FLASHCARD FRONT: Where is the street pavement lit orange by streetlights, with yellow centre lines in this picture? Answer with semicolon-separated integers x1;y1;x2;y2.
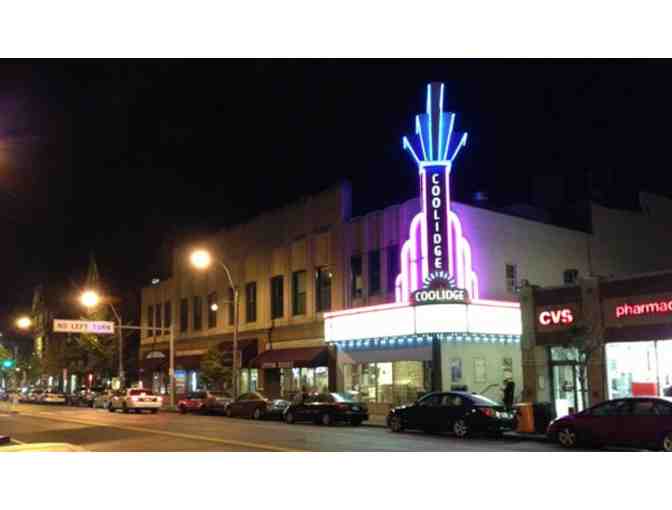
0;404;561;452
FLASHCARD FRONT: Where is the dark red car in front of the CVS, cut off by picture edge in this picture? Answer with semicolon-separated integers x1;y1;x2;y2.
547;397;672;452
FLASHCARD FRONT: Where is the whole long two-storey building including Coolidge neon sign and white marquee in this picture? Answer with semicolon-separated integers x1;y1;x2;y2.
140;84;672;412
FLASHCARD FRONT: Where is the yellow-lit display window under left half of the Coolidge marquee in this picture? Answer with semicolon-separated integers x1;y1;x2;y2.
343;361;431;405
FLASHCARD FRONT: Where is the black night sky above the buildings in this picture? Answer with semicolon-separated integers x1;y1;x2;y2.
0;60;672;331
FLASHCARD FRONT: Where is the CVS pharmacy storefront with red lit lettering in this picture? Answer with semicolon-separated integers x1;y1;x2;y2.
521;272;672;415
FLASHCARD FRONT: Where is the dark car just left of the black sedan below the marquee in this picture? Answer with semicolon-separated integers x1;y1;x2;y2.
284;393;369;425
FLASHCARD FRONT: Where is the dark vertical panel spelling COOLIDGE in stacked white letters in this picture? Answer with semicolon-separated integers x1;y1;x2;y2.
424;165;449;273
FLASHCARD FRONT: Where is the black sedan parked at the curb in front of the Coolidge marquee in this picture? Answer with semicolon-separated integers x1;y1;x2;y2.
387;391;513;438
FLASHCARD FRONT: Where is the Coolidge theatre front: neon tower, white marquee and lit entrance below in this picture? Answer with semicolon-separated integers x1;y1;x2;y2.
325;84;522;408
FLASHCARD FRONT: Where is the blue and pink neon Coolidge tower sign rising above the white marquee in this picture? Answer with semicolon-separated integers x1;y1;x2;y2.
395;83;478;304
